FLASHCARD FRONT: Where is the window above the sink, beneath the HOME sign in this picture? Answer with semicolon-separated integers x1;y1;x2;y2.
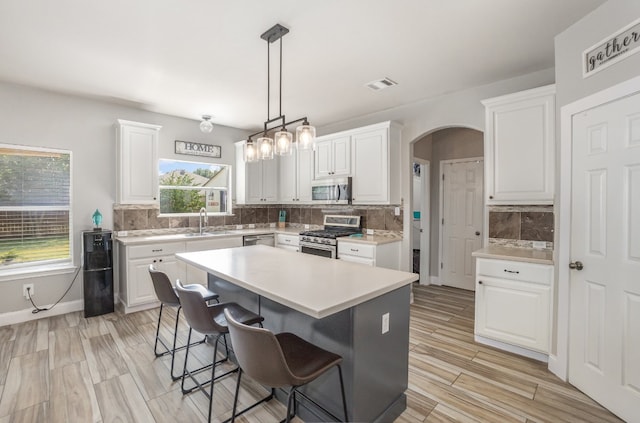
158;159;231;214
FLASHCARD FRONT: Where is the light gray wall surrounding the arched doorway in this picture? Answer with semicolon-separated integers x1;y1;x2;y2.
318;69;554;271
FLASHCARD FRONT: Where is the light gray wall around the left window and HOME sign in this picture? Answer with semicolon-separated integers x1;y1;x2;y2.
0;83;247;316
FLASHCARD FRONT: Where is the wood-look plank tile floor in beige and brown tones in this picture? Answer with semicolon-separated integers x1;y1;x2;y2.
0;286;620;423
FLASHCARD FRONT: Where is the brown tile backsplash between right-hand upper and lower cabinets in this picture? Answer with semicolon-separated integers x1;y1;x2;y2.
489;206;554;250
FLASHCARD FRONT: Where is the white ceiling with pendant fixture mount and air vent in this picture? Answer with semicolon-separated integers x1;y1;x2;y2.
0;0;604;130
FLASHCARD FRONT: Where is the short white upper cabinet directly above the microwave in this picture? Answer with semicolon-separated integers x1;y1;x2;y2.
315;135;351;179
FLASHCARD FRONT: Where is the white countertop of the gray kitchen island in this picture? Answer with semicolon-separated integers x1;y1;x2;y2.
176;245;418;319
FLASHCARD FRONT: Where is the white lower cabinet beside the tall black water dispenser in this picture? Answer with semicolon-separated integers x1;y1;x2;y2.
118;242;186;313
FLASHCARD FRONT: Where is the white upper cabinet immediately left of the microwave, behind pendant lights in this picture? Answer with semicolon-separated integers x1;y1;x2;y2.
279;149;313;204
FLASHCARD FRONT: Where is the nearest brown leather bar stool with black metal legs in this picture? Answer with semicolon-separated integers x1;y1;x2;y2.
225;311;349;423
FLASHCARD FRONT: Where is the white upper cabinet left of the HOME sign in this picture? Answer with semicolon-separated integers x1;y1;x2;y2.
116;119;162;204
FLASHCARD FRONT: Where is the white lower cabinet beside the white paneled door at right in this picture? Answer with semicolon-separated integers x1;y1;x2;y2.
475;258;553;354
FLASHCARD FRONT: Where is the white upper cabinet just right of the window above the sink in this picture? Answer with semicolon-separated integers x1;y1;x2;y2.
236;141;279;204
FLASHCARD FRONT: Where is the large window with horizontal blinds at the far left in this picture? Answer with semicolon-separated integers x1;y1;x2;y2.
0;144;71;271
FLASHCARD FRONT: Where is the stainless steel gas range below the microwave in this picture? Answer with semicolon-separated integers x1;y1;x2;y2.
300;214;362;258
